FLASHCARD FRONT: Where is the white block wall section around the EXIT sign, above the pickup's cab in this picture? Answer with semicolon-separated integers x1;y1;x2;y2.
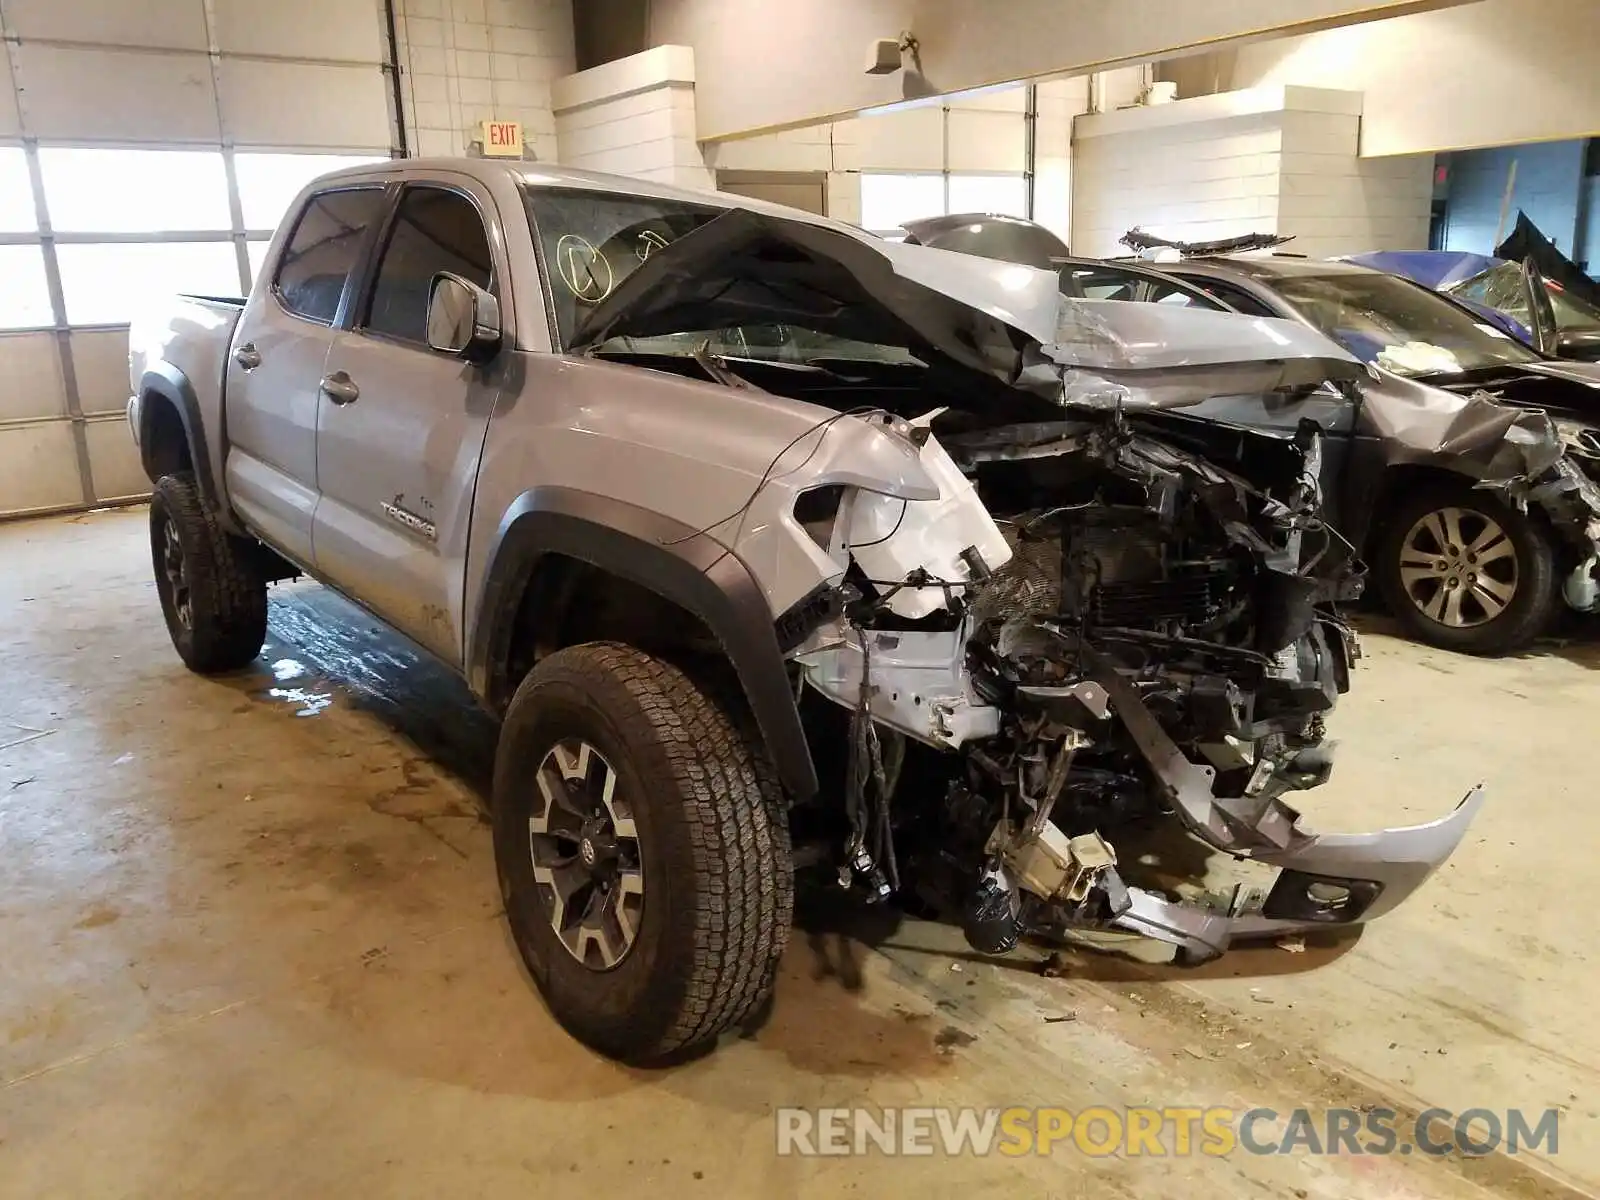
395;0;573;162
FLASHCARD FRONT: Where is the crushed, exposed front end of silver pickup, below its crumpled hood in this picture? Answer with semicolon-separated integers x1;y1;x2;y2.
780;408;1480;960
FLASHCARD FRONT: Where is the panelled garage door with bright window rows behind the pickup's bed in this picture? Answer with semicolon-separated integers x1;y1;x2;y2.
0;0;392;515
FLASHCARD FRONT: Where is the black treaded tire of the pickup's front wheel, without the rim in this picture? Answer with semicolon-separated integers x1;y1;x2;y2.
493;642;794;1066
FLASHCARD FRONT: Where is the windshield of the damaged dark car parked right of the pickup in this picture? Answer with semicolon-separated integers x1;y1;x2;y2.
1275;270;1539;378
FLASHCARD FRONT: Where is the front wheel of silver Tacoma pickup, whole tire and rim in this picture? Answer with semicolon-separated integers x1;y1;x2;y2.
494;642;794;1064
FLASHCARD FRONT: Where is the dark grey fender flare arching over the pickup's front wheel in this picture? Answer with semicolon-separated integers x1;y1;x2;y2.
467;486;818;800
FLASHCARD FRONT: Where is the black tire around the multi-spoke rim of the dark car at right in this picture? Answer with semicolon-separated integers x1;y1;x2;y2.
1376;485;1562;656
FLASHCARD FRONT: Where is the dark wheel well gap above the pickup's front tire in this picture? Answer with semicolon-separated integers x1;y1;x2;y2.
490;554;722;710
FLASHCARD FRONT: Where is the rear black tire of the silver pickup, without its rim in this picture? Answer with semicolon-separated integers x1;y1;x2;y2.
150;472;267;675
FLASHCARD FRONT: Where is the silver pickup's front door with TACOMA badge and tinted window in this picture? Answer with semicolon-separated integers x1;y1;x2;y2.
314;186;510;664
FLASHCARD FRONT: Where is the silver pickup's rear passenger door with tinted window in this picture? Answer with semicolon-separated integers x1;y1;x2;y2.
226;187;384;563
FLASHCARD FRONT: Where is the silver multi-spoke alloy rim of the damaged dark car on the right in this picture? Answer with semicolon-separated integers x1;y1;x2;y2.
1400;507;1517;629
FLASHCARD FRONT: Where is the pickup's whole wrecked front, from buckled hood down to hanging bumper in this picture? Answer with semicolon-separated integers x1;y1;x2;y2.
574;211;1482;960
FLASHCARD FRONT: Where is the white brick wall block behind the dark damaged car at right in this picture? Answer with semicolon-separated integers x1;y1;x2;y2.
1072;88;1434;258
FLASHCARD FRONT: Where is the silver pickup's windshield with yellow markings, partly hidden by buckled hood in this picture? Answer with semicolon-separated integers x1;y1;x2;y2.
525;187;920;365
